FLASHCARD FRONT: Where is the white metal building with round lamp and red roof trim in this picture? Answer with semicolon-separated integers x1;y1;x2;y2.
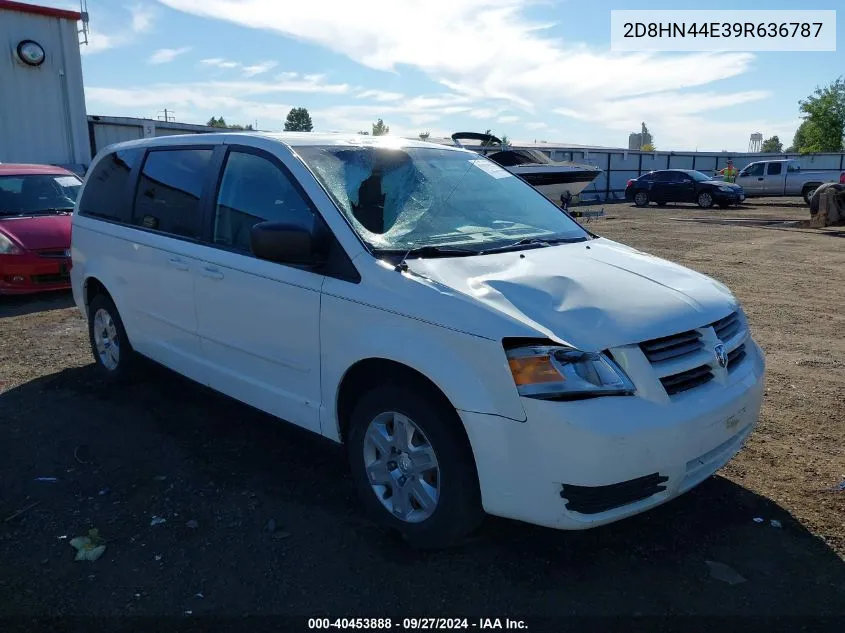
0;0;91;170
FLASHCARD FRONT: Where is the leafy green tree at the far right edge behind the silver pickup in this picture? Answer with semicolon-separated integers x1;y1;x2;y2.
793;76;845;153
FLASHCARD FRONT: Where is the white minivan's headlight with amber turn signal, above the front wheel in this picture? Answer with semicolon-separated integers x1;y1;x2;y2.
507;345;635;400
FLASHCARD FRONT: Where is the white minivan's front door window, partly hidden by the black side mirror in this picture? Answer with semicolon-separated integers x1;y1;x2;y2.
214;151;314;252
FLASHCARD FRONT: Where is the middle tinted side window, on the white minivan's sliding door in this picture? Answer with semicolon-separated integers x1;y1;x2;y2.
132;149;212;239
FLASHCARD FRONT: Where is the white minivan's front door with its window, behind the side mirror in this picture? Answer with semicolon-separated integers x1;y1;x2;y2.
196;147;324;432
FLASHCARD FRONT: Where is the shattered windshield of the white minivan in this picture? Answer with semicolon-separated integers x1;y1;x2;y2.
295;146;588;250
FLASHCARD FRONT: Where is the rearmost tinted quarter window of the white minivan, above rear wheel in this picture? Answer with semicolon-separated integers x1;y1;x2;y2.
79;147;144;223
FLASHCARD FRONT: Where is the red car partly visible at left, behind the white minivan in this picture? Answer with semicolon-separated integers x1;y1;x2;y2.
0;163;82;295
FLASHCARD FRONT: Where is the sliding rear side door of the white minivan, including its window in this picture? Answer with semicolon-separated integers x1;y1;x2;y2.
122;146;214;382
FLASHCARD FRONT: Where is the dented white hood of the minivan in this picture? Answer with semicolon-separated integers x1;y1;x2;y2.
408;239;737;351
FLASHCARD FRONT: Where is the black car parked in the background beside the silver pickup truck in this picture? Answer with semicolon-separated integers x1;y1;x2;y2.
625;169;745;209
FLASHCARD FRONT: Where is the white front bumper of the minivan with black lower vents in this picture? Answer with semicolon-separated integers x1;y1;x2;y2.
460;338;764;530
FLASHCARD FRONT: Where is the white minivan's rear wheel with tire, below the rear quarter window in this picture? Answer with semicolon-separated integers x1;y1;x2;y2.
88;294;138;382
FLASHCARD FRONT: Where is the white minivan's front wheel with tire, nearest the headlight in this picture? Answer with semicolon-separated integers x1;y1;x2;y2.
347;382;484;549
